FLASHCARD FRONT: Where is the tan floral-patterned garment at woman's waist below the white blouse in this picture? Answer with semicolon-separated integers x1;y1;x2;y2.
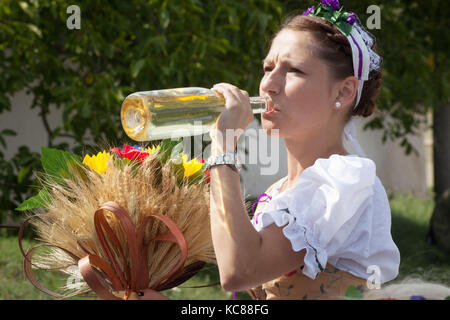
247;264;366;300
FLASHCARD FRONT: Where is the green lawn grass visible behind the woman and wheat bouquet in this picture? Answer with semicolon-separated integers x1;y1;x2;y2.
0;194;450;300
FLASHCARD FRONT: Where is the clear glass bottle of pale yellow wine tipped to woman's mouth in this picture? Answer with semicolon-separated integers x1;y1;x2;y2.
120;87;266;141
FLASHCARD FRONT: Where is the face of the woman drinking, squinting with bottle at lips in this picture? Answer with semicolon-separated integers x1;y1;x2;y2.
259;29;336;139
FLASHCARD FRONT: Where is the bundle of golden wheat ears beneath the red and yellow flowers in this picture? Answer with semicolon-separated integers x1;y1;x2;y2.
20;145;214;298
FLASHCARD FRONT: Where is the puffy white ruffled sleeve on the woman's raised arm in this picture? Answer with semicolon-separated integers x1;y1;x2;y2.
252;155;376;279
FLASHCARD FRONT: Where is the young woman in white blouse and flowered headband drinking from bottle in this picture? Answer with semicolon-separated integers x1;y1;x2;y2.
208;1;400;299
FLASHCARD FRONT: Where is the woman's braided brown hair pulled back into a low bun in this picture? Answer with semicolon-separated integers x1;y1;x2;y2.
280;15;382;117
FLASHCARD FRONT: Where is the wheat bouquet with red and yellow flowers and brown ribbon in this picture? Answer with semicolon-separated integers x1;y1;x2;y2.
17;139;215;299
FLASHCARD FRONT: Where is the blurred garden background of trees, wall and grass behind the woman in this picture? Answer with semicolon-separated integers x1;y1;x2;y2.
0;0;450;299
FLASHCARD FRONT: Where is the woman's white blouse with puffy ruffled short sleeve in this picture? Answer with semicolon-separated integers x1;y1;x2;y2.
252;155;400;283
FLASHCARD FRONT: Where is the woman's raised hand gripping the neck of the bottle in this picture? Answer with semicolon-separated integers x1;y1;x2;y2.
210;83;253;153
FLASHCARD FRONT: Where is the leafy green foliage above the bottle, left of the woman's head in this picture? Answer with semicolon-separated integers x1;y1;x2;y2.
0;0;283;220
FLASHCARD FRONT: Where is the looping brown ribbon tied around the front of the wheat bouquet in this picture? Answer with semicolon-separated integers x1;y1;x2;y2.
19;201;205;300
